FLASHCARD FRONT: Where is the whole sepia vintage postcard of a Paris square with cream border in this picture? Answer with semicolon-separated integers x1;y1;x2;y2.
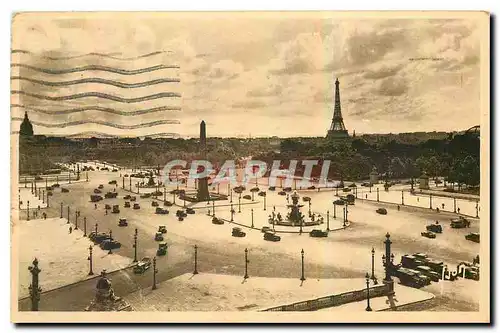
11;11;490;323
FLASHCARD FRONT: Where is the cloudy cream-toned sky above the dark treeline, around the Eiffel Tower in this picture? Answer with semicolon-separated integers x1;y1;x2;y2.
11;12;484;137
